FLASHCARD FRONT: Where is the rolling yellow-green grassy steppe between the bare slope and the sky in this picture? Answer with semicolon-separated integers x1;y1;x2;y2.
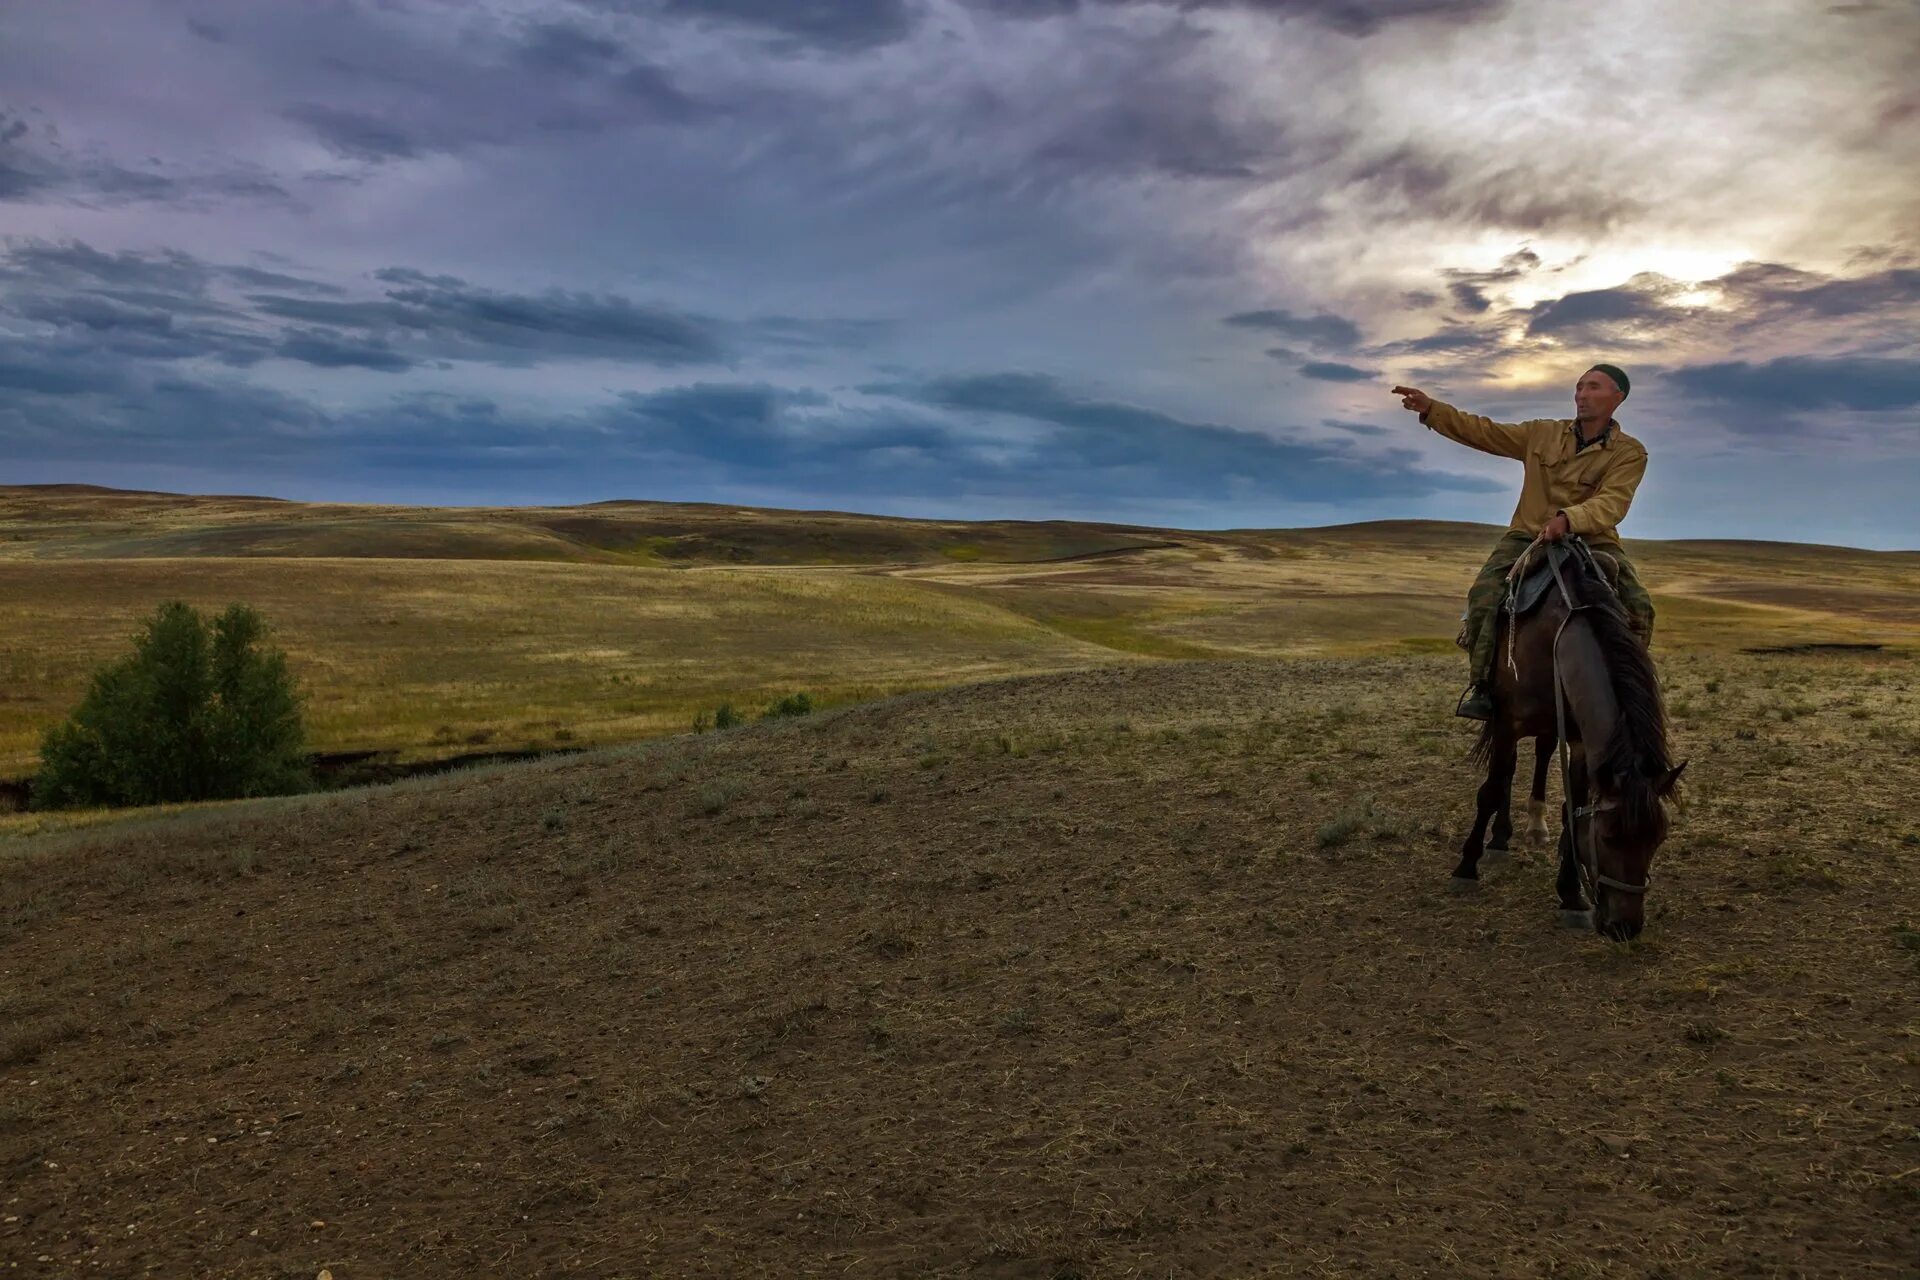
0;487;1920;777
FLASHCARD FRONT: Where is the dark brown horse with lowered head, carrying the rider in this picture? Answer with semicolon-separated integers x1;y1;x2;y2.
1453;537;1686;940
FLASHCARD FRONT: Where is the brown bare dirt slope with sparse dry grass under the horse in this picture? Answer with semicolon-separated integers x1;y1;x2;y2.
0;652;1920;1280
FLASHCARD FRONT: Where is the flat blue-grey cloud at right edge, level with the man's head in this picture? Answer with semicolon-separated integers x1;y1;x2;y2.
1667;355;1920;416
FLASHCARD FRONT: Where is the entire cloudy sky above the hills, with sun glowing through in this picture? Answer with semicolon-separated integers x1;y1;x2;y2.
0;0;1920;547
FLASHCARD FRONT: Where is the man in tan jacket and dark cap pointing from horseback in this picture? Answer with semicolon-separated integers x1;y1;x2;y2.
1394;365;1653;720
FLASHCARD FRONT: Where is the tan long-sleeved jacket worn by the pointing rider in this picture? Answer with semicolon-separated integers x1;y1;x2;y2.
1421;401;1647;543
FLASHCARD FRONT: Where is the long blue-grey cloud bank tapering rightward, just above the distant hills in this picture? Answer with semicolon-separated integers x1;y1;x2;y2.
0;353;1494;505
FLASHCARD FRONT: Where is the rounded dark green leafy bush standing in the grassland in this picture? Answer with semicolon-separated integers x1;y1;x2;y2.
33;601;307;808
